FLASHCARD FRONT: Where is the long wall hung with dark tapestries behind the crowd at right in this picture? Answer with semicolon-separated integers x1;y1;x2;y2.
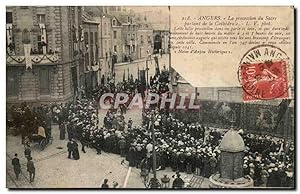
173;69;295;138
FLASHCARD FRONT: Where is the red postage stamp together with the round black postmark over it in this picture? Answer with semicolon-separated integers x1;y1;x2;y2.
238;45;290;101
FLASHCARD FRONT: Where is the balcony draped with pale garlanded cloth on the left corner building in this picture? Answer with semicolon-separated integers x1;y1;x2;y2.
6;53;59;66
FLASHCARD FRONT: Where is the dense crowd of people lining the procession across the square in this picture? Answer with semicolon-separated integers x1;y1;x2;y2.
8;67;295;187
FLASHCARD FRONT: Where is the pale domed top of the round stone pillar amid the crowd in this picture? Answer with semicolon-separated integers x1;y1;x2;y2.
219;129;246;152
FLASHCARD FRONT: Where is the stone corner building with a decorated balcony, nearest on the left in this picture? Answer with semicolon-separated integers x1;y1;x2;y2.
6;6;81;104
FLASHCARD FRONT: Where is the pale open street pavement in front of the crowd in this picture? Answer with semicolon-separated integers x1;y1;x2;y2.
6;105;208;188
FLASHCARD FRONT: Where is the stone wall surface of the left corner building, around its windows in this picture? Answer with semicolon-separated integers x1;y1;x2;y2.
7;6;78;104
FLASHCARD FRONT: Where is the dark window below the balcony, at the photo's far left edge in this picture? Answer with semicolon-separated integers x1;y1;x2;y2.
6;69;19;96
